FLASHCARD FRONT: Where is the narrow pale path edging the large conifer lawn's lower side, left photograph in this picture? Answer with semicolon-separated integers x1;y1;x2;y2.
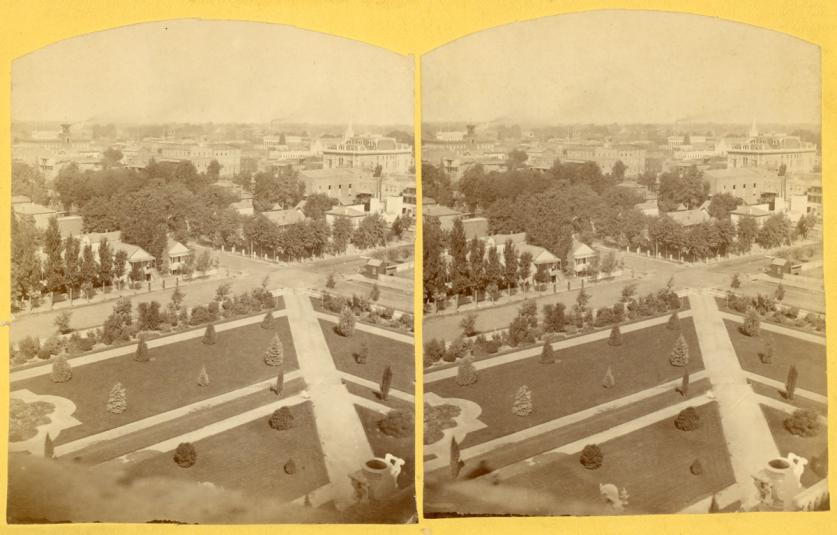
53;370;302;457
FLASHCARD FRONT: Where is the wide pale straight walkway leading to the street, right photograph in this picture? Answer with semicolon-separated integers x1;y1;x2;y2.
689;291;779;507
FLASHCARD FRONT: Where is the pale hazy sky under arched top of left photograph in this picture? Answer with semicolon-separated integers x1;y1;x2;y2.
12;20;413;124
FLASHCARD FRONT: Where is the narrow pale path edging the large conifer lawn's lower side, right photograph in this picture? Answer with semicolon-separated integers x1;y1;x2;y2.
424;371;706;472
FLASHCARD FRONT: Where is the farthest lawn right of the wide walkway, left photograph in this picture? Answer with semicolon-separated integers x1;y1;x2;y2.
319;319;415;394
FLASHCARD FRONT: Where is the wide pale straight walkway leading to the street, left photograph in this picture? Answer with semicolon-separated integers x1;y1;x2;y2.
285;292;374;510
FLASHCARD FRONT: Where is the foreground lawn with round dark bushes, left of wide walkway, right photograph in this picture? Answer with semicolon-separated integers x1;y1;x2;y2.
501;402;735;514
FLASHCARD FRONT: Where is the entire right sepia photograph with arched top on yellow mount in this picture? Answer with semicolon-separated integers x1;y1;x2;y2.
421;11;829;518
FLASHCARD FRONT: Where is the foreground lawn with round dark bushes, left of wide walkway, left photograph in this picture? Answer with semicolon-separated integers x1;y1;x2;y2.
126;402;328;502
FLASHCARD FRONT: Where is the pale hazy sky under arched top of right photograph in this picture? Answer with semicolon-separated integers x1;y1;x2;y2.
422;11;820;123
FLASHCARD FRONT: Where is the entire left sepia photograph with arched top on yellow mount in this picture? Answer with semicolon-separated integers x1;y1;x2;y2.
7;20;417;524
